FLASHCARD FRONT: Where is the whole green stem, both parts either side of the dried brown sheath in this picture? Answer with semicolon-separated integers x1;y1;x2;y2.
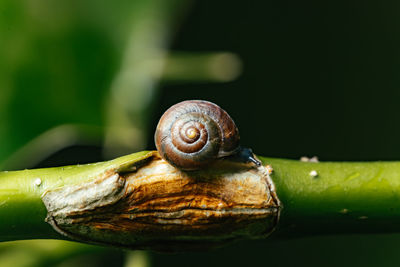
0;152;400;241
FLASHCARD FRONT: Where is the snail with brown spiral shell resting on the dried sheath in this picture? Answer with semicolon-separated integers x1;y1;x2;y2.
154;100;261;170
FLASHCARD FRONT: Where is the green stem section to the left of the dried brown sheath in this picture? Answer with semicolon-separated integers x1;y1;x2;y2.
0;152;151;241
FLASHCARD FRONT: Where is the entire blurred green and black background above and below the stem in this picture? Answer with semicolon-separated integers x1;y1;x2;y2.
0;0;400;267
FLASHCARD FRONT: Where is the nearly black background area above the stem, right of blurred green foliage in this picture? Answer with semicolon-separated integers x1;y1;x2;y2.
155;1;400;161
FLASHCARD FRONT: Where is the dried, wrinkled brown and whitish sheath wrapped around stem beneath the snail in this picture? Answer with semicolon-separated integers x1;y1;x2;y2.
42;153;279;250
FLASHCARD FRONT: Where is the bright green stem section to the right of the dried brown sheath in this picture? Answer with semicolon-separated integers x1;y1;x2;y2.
263;158;400;236
